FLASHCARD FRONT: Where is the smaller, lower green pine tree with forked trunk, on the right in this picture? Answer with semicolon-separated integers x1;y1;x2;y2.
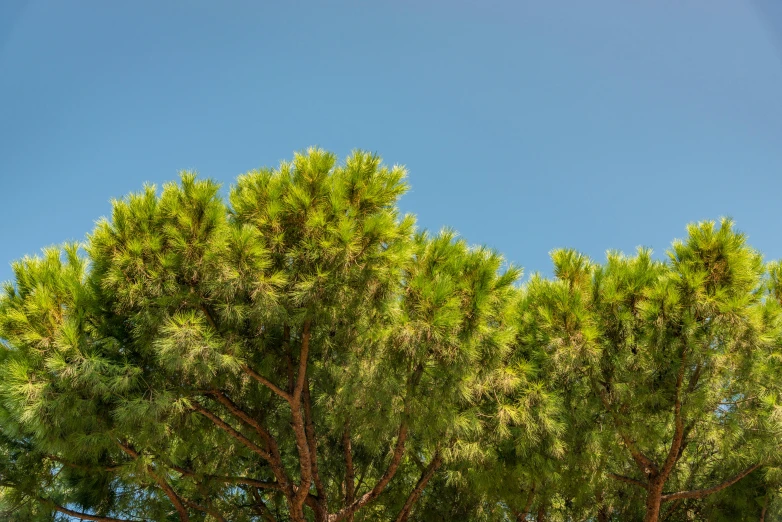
525;220;780;521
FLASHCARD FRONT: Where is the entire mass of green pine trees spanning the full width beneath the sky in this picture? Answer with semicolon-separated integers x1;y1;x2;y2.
0;149;782;522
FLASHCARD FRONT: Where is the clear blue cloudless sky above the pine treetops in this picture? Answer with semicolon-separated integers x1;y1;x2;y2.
0;0;782;280
